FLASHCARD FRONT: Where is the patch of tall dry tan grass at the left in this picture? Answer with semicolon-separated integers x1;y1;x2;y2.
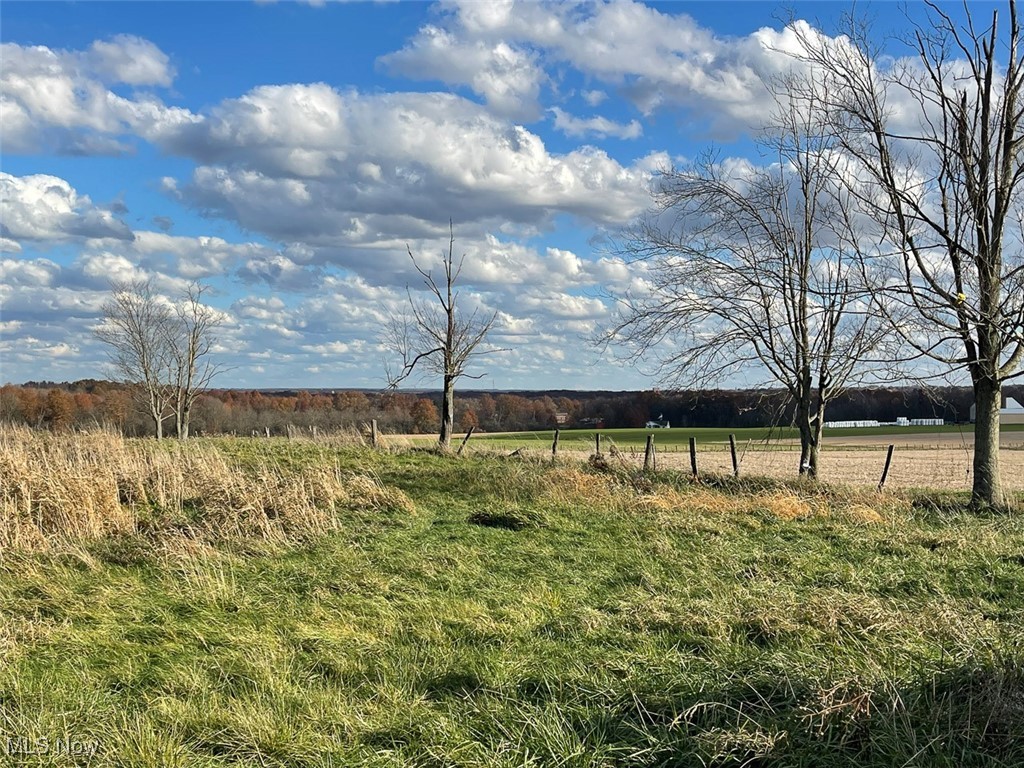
0;426;415;550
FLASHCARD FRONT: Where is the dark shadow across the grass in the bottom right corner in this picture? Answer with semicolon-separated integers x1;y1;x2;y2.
454;663;1024;767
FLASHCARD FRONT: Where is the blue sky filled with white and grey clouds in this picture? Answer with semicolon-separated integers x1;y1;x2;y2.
0;0;995;389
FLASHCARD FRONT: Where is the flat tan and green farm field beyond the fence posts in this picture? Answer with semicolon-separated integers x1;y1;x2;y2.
438;424;1024;490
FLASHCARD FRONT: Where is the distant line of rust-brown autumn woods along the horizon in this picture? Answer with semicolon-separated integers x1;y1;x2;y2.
0;379;1024;436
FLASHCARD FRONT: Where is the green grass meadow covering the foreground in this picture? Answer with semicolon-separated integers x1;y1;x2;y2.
0;442;1024;767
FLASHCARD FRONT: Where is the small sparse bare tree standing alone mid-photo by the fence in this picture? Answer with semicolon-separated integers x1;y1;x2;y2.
383;222;498;451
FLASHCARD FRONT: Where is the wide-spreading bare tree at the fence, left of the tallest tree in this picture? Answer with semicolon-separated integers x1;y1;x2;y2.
604;76;885;478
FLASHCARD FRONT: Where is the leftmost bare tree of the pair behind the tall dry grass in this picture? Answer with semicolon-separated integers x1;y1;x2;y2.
94;281;175;440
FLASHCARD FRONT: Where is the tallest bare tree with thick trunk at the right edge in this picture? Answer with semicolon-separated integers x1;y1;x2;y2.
804;0;1024;506
